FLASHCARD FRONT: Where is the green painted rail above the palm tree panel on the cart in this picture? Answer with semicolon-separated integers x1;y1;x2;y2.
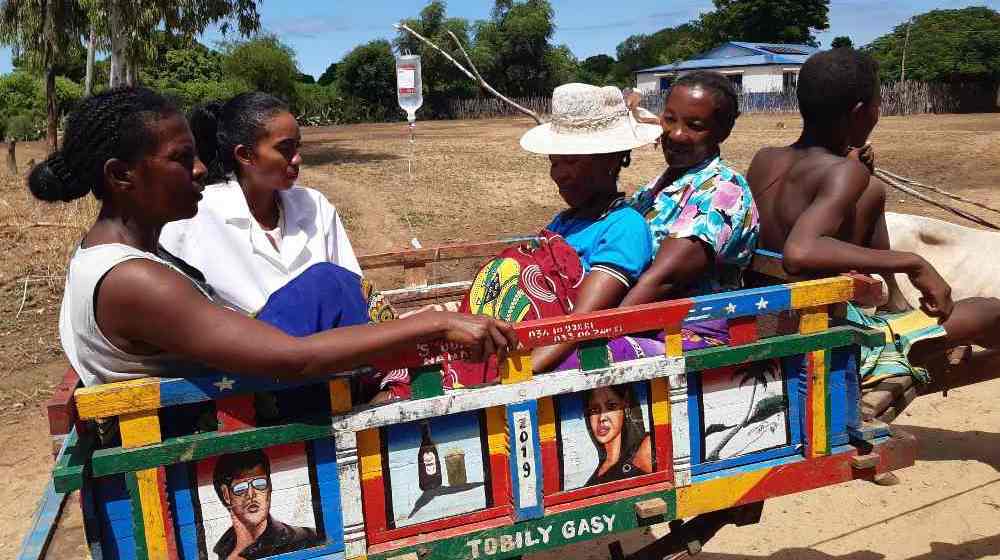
684;327;882;372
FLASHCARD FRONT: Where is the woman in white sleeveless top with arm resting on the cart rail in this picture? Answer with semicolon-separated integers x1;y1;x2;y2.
29;88;517;385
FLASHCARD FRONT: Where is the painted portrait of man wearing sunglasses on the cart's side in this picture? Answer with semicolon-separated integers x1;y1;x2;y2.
212;450;320;560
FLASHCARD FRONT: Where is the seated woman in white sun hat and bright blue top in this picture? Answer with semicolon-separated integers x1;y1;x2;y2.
450;84;662;385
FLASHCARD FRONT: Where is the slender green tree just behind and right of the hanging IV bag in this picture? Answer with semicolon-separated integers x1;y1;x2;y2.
393;0;477;116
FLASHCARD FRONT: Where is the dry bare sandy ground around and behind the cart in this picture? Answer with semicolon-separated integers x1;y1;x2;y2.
0;114;1000;560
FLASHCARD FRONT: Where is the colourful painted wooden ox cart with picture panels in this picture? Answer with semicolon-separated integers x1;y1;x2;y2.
22;242;928;560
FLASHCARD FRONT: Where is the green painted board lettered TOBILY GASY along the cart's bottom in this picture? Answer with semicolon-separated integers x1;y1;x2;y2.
368;490;677;560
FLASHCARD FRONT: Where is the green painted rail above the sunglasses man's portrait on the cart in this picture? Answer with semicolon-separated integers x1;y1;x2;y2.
91;418;333;476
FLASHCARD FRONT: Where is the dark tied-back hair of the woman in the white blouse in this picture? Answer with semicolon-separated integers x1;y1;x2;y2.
188;91;289;183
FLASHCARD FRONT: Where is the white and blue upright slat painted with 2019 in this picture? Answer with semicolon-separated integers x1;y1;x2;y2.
507;401;543;521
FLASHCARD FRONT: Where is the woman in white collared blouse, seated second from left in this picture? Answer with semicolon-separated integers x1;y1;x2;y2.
160;92;361;314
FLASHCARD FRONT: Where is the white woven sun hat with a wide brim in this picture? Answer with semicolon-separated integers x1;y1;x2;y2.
521;84;663;155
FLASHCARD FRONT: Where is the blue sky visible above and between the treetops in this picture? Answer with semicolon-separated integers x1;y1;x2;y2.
0;0;1000;77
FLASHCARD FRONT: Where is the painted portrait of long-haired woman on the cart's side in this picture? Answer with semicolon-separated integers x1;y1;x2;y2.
584;385;653;486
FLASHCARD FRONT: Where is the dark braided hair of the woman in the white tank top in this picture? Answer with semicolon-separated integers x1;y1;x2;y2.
28;87;178;202
